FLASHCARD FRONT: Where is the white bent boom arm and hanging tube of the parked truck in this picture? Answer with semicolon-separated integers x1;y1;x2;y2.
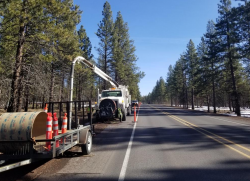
69;56;119;130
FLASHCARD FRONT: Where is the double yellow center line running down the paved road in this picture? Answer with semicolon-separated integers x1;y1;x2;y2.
150;106;250;159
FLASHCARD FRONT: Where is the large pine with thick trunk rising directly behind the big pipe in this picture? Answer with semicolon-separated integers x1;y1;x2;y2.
0;0;50;112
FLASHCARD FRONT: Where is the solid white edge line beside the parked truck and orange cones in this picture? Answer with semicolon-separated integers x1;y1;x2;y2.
118;108;140;181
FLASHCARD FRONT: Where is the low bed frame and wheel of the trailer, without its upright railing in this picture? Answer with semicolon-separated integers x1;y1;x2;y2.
0;125;92;172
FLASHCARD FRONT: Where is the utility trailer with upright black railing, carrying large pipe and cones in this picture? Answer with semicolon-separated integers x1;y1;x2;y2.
0;101;94;173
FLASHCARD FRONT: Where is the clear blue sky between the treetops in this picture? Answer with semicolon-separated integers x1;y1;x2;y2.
74;0;243;95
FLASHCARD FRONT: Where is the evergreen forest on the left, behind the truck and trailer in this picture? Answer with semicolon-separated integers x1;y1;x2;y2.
0;0;144;112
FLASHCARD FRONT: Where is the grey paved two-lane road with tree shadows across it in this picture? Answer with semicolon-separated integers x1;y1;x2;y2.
21;105;250;181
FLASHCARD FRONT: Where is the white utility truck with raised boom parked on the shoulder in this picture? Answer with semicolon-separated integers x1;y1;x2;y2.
69;56;131;121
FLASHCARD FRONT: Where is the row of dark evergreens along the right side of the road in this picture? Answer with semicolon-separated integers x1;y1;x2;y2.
142;0;250;116
